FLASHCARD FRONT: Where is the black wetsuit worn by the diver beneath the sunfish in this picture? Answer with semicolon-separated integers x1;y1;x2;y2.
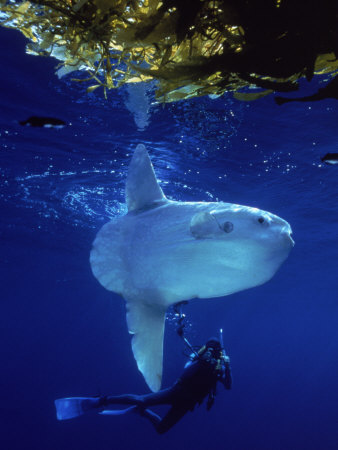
101;348;232;434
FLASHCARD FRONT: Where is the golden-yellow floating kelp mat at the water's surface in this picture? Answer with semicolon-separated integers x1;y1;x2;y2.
0;0;338;101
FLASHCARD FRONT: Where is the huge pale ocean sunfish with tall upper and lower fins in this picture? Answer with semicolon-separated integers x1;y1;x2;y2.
90;144;294;391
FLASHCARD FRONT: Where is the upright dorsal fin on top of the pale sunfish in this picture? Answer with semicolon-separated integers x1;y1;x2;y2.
126;144;166;211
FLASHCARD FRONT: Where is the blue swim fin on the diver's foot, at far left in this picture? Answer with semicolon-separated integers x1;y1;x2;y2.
55;397;102;420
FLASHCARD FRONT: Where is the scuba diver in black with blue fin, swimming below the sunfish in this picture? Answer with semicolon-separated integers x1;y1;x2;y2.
55;337;232;434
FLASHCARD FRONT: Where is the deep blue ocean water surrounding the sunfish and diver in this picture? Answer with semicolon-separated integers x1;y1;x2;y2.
0;29;338;450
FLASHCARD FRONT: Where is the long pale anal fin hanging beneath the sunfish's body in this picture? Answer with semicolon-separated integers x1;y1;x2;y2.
127;299;165;391
